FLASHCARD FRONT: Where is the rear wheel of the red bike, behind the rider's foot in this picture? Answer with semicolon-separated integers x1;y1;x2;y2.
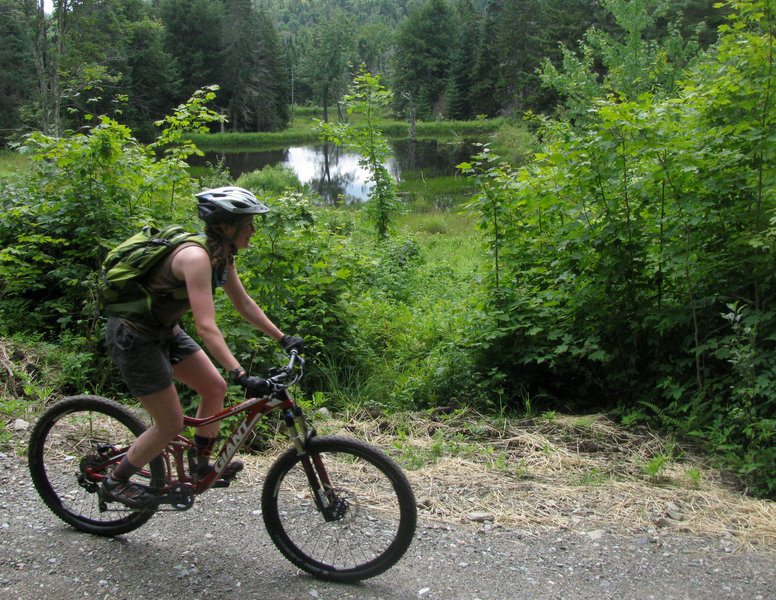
28;396;166;536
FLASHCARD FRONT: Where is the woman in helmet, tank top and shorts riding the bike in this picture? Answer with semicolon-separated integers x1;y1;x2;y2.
101;187;304;508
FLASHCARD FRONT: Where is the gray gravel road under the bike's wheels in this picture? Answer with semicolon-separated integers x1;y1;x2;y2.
0;455;776;600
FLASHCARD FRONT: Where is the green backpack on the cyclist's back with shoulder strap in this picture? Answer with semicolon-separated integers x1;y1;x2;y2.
99;225;208;322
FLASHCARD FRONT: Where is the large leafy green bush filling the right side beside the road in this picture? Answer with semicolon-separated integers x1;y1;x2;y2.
462;2;776;495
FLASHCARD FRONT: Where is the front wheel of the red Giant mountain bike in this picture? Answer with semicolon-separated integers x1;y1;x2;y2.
262;436;417;583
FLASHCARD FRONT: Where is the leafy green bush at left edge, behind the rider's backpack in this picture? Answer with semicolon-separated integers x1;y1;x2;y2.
0;91;220;339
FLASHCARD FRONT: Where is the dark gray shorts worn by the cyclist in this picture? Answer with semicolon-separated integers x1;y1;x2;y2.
105;317;201;398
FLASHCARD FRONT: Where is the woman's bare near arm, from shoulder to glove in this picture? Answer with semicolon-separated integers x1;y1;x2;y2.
172;246;240;371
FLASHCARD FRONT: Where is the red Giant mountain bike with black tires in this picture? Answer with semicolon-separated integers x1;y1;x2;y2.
28;352;417;583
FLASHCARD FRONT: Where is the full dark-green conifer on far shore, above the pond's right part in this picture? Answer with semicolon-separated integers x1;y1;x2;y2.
392;0;456;119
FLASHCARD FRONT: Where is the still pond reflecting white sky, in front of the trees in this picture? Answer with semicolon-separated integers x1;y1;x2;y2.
197;139;477;202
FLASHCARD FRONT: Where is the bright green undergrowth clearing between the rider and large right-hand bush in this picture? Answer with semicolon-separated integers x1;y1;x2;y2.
327;204;484;411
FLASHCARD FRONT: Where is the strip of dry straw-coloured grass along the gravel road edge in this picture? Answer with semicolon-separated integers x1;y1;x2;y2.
239;412;776;549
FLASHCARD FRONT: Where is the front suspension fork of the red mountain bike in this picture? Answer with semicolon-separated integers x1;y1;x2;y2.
283;406;348;522
